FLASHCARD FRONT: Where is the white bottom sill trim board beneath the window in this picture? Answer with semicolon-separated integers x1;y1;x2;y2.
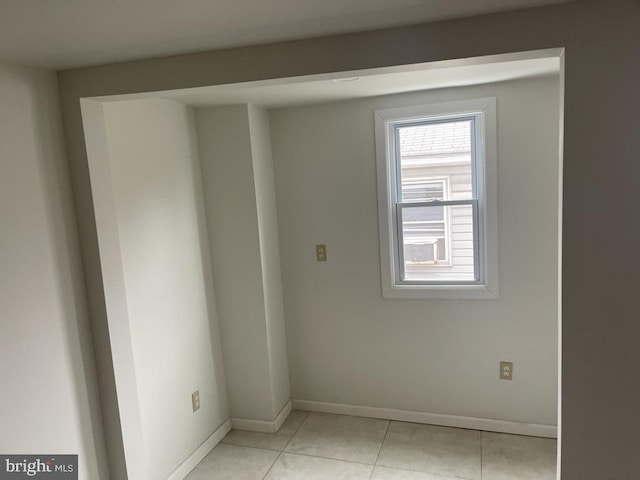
382;285;499;300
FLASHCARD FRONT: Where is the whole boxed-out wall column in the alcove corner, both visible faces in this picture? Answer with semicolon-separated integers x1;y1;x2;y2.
196;105;290;427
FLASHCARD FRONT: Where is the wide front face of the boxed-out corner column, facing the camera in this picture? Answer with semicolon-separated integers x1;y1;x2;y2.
196;105;272;421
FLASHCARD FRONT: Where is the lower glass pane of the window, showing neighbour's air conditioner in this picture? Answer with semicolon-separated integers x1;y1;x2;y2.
400;204;476;282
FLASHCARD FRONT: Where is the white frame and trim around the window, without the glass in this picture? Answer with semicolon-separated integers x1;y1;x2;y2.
375;97;499;299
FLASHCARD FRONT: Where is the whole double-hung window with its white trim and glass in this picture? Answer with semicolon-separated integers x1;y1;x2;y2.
376;98;498;298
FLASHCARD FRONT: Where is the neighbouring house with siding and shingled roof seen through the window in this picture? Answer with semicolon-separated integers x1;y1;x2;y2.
395;118;477;281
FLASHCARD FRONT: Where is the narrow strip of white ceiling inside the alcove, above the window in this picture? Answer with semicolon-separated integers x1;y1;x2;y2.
99;49;560;108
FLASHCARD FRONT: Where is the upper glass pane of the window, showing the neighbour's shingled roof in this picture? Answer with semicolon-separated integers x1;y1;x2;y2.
397;119;473;202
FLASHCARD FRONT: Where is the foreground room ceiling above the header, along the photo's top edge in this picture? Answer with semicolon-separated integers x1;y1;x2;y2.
0;0;567;69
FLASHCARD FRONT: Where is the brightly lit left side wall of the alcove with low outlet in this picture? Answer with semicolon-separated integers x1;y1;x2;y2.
98;100;228;480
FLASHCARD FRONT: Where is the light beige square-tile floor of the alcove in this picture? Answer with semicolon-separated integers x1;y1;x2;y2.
187;411;556;480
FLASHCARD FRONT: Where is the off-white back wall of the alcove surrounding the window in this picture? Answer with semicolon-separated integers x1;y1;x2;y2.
270;77;559;424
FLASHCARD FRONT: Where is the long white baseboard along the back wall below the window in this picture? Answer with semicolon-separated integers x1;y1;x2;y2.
292;400;558;438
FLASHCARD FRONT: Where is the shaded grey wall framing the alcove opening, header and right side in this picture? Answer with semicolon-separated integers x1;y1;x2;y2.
59;0;640;480
